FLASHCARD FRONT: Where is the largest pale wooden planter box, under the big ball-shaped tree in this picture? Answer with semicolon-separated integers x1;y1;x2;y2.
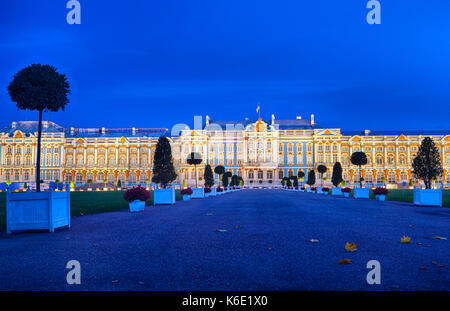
6;190;70;234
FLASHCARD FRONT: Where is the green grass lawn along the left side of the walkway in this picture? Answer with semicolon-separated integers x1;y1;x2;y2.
0;190;182;231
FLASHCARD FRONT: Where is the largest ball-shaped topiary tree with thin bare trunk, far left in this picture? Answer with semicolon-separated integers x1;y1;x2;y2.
8;64;70;192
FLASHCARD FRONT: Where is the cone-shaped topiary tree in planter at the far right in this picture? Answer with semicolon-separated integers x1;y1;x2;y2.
412;137;443;189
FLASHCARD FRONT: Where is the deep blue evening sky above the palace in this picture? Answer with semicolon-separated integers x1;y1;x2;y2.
0;0;450;130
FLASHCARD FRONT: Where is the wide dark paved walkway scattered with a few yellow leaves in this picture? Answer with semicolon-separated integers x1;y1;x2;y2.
0;190;450;290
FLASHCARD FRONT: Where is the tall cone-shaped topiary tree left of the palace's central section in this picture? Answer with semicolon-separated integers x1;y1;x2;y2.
152;136;177;188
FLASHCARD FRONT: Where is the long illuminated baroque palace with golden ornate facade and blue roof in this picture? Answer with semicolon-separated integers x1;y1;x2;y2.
0;115;450;187
